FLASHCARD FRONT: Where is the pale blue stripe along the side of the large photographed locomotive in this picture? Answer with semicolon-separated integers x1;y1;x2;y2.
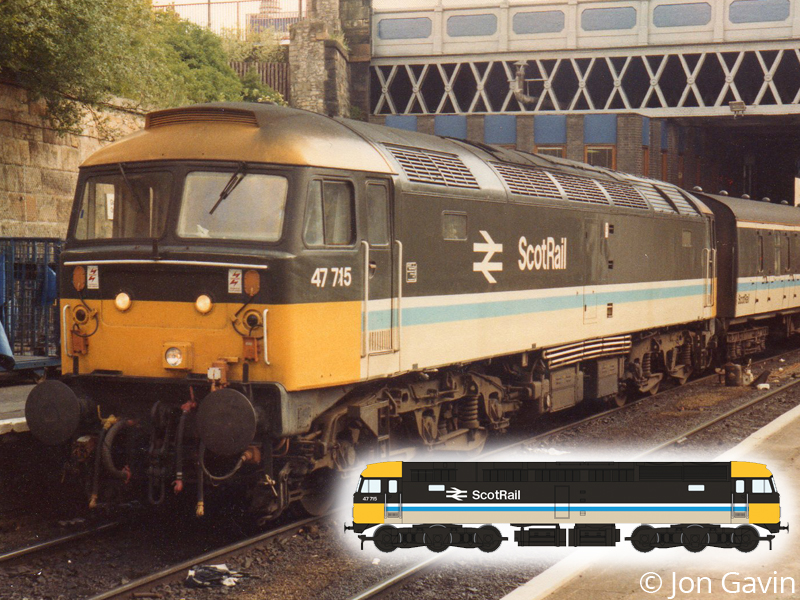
369;284;705;331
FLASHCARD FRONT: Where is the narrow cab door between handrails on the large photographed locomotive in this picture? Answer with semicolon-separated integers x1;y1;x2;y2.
361;180;400;378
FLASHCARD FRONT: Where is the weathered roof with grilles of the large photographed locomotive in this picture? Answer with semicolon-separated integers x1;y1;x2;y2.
82;102;708;217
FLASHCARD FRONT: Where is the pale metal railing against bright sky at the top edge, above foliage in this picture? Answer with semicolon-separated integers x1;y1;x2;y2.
153;0;306;38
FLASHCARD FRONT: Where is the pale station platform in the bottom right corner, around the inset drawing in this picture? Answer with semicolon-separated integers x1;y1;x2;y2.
503;406;800;600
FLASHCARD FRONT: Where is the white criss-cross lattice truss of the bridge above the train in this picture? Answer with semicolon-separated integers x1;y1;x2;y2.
372;42;800;117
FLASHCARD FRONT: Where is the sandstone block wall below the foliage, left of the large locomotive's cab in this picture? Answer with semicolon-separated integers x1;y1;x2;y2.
0;82;144;238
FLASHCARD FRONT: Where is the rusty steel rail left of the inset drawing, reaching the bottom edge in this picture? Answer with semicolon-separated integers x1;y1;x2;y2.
86;513;324;600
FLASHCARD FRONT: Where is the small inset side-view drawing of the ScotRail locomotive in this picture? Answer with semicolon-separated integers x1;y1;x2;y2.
346;461;789;552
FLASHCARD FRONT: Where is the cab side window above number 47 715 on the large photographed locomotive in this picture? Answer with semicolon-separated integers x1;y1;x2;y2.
303;180;356;246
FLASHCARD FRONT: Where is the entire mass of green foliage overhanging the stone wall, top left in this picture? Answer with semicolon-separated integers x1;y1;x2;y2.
0;0;270;131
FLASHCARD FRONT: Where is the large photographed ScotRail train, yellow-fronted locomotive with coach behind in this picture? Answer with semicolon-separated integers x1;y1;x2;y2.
20;103;800;519
